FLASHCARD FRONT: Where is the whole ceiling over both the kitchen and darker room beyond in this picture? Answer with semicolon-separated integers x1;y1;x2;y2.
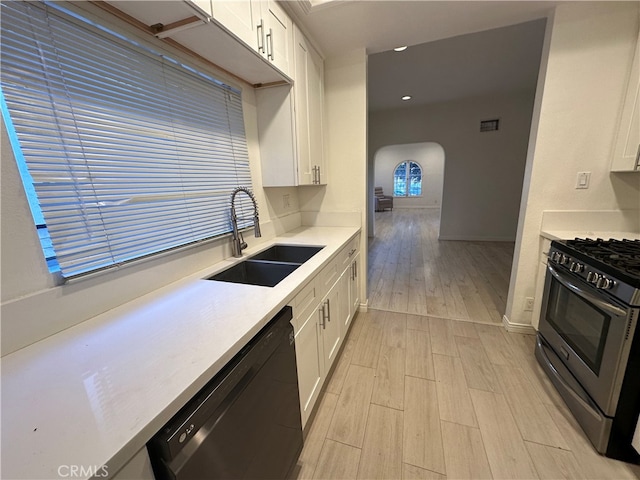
287;0;560;111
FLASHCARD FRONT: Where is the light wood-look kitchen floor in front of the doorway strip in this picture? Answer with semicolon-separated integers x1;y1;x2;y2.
292;310;640;480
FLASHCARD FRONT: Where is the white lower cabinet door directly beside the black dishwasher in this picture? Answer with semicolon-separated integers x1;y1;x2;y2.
296;309;324;427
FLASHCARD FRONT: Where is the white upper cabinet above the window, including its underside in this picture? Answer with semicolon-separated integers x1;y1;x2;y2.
107;0;293;86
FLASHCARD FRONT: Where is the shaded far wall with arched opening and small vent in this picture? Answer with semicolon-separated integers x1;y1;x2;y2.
369;92;534;241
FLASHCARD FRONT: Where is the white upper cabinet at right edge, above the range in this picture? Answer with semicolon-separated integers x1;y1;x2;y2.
611;32;640;172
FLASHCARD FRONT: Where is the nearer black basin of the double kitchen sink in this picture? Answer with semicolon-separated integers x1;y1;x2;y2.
207;259;301;287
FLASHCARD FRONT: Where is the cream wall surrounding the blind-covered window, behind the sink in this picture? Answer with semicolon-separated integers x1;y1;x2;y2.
0;5;300;355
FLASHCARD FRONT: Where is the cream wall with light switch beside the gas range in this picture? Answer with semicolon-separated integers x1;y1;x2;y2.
506;2;640;325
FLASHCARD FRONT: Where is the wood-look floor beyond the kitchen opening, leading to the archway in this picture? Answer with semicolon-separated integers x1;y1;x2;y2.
368;209;514;323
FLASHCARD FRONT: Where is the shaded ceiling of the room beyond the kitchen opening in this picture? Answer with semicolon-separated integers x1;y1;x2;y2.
367;20;545;111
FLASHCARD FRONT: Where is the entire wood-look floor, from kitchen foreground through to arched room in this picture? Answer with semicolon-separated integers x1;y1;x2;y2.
292;210;640;480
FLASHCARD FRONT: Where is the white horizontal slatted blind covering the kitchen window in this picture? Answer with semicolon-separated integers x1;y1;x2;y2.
0;1;251;278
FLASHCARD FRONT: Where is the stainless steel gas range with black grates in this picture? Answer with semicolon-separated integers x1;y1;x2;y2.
536;239;640;463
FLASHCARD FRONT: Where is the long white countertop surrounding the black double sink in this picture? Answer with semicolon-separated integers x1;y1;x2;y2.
1;227;358;479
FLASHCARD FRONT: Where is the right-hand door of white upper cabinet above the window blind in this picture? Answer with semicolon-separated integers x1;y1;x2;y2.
262;0;293;76
